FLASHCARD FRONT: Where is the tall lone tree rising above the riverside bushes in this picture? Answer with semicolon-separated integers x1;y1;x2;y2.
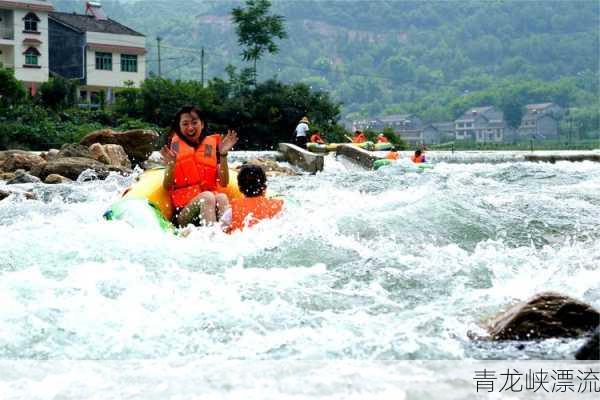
231;0;287;85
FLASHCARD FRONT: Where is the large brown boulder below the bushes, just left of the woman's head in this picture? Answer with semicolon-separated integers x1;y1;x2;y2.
79;129;159;164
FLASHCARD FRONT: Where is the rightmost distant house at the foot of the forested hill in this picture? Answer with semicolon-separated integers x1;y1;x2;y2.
518;103;564;139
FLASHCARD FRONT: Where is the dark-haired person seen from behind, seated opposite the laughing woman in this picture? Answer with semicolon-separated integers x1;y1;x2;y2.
221;164;283;233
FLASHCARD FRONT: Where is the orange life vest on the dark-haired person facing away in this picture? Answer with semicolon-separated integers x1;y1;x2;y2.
229;196;283;232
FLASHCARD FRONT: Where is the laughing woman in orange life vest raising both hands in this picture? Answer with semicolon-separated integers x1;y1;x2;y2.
160;106;238;226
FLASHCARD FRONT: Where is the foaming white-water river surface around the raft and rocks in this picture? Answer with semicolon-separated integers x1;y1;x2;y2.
0;152;600;396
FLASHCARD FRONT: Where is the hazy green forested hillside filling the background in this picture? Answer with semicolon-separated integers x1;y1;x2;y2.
53;0;600;126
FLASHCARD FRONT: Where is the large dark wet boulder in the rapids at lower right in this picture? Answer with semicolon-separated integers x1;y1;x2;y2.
488;292;600;340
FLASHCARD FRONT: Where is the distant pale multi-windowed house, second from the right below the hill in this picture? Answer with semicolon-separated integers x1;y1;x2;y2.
454;106;508;143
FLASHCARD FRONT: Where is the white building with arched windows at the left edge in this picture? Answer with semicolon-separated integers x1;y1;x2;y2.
0;0;54;95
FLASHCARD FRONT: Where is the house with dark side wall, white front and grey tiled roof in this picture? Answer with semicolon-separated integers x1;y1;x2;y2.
49;2;146;104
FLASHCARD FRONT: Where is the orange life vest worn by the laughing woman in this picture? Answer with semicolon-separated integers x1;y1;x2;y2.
169;134;221;208
